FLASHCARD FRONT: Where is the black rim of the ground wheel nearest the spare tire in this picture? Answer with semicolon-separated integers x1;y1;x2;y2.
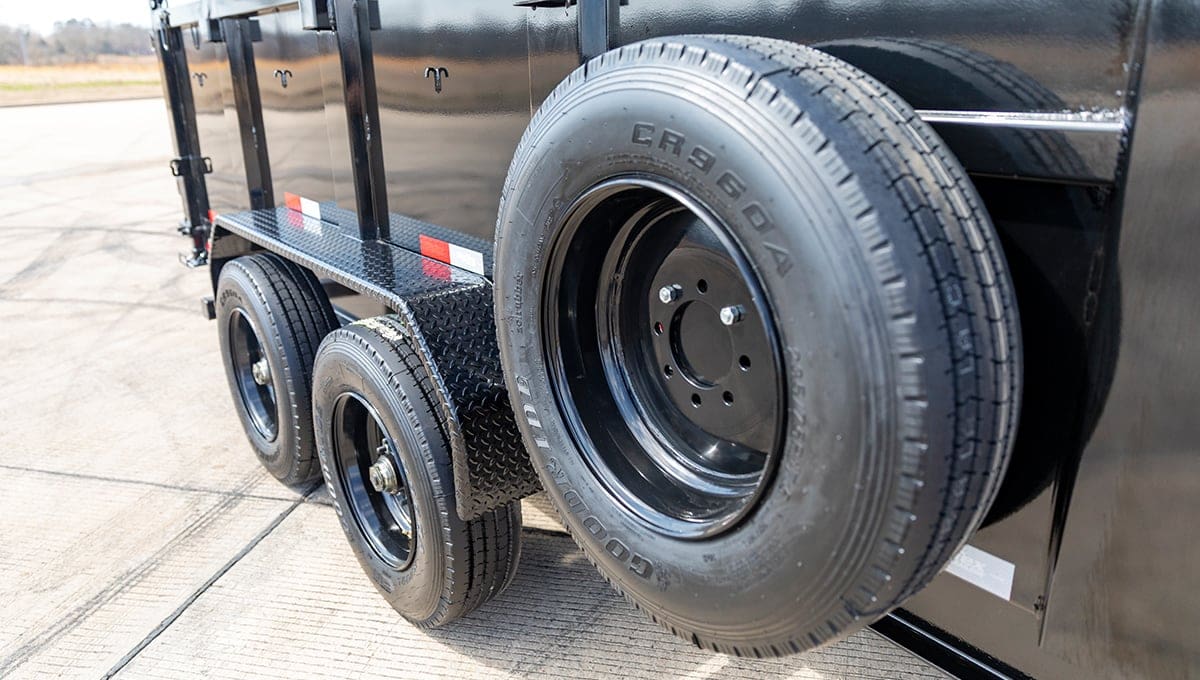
332;392;416;570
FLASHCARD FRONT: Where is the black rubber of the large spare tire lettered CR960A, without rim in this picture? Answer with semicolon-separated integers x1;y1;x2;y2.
494;36;1021;656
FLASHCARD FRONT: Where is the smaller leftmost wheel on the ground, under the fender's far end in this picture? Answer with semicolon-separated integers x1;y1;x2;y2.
216;253;338;486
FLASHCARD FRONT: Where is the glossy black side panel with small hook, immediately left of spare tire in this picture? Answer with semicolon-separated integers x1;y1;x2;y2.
371;0;530;240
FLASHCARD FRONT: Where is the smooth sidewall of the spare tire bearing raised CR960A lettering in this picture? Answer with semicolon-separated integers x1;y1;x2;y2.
496;71;892;640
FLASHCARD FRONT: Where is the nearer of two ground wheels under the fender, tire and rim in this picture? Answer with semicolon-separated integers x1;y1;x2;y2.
313;317;521;627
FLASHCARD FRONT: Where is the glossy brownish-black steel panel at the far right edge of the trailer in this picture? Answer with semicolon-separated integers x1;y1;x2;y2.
1044;0;1200;679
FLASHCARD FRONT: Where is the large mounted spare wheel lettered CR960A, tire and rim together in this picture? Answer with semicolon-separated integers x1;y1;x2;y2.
496;36;1020;656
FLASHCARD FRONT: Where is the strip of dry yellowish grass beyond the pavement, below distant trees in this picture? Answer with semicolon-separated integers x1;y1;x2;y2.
0;56;162;107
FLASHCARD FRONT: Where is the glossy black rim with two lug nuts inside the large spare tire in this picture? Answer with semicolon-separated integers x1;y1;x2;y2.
542;176;785;537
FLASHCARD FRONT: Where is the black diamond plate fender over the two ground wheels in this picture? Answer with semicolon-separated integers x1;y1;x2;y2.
210;204;541;519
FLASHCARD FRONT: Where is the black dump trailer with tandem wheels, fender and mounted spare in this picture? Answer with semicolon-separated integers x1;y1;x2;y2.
154;0;1200;679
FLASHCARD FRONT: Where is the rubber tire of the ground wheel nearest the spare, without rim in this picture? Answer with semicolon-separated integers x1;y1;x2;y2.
313;317;521;627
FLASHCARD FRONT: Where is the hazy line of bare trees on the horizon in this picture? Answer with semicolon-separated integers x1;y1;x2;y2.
0;19;154;66
